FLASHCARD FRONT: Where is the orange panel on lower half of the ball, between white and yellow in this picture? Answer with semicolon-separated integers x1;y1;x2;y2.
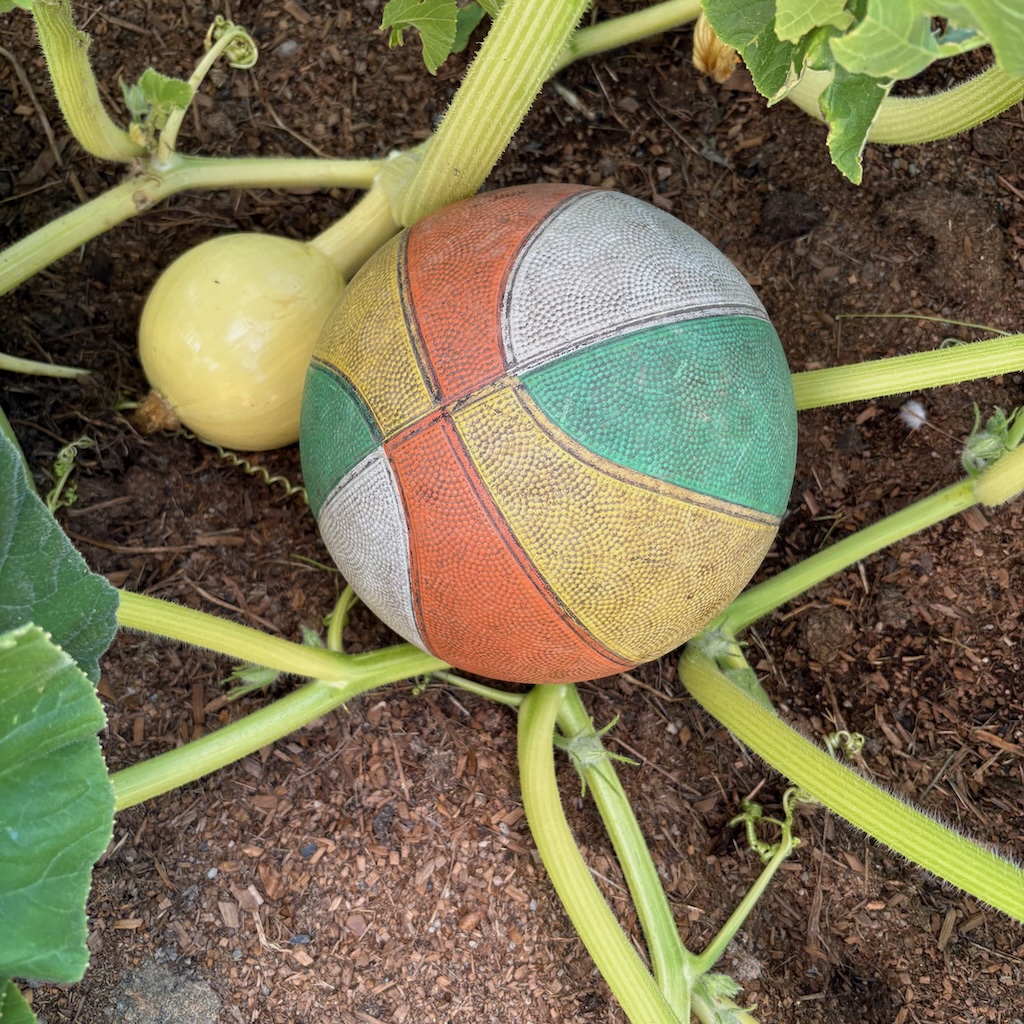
384;413;632;683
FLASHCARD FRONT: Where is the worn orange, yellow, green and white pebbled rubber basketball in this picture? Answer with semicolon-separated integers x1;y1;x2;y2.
301;185;797;683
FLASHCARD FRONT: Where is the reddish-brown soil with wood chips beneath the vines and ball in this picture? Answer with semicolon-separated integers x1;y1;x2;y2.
0;0;1024;1024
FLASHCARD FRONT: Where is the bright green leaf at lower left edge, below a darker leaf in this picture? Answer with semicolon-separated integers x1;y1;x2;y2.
0;625;114;982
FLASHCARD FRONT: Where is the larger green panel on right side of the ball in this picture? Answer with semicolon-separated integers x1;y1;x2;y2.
521;316;797;517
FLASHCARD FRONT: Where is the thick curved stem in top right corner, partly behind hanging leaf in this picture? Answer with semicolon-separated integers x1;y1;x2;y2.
785;68;1024;145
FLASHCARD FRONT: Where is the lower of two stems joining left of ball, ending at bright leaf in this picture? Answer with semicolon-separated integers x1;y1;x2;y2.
111;644;435;811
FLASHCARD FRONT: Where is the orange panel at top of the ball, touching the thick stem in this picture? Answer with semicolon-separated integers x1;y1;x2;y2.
402;184;587;402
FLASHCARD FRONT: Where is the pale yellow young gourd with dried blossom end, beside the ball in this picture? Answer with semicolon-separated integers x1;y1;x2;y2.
139;233;344;452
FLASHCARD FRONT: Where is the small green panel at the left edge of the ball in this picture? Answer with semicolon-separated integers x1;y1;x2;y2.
299;362;381;516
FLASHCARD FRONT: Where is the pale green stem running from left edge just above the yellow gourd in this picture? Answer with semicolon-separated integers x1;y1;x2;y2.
0;156;383;295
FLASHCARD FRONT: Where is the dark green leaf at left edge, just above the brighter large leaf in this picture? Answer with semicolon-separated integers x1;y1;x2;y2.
0;433;118;682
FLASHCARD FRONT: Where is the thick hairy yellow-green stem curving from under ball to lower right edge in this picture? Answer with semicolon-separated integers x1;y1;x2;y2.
679;647;1024;921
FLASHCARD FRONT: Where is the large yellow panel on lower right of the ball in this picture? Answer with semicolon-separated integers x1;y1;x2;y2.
453;383;776;663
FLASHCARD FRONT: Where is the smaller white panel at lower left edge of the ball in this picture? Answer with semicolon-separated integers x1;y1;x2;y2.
319;449;424;647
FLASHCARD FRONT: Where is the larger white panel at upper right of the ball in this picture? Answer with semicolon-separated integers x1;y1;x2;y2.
502;191;768;373
